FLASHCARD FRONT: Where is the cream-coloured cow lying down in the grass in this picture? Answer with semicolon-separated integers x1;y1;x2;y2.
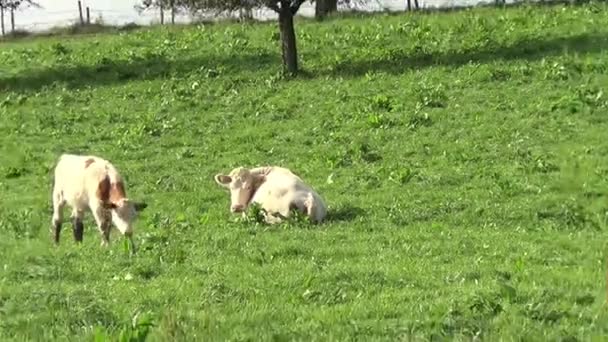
215;166;327;224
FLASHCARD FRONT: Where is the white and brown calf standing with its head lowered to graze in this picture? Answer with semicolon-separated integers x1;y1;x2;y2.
52;154;146;248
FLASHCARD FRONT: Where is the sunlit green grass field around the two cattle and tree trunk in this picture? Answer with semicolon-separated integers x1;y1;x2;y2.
0;3;608;341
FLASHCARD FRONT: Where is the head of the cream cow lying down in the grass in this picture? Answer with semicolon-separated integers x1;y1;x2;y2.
215;167;265;213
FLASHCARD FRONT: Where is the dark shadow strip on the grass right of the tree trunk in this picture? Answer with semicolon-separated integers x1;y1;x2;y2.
326;33;608;77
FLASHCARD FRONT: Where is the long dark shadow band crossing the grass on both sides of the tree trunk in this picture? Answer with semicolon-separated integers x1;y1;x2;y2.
0;33;608;91
